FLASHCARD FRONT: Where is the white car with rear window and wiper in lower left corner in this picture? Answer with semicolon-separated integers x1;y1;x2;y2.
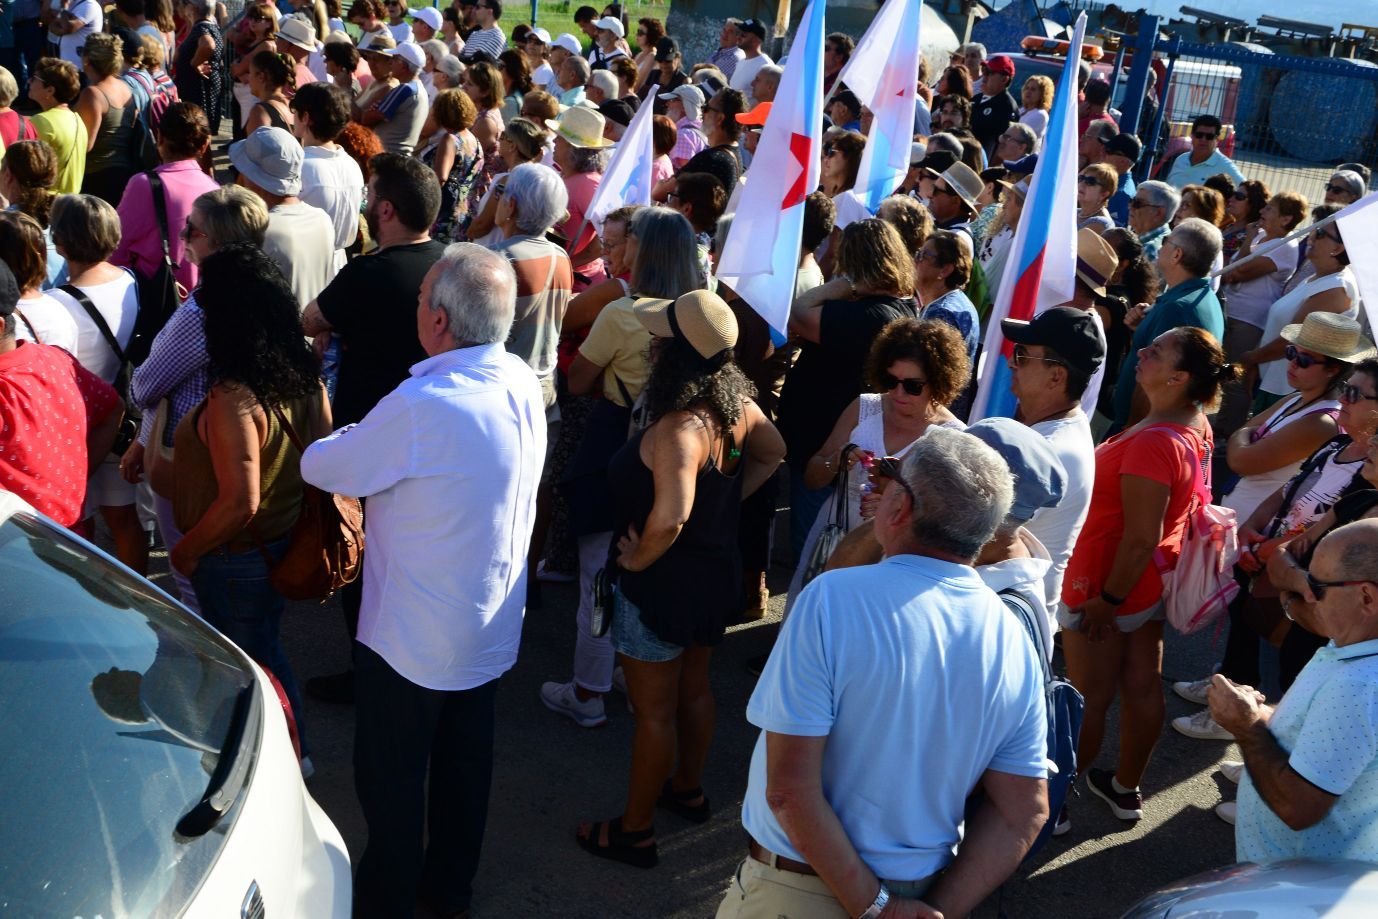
0;492;351;919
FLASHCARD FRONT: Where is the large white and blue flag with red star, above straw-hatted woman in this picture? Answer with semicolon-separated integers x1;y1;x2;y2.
718;0;825;340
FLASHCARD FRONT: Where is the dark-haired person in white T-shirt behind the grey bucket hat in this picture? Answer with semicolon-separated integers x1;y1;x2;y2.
292;83;364;270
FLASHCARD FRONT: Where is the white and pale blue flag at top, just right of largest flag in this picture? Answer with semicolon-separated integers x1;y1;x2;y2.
838;0;923;214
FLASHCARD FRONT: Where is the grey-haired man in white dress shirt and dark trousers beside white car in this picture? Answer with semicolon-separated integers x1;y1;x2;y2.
302;242;546;916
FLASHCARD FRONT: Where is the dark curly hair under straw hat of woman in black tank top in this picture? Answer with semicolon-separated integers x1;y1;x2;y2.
646;338;757;426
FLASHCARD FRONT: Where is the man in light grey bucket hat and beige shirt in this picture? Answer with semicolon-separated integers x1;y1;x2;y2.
230;127;339;309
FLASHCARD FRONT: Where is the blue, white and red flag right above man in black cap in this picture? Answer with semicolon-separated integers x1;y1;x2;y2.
971;12;1086;422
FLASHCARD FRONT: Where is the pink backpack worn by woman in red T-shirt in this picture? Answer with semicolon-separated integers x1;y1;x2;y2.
1145;424;1239;635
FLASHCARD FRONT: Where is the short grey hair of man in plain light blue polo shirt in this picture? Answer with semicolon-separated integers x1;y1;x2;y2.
900;427;1014;562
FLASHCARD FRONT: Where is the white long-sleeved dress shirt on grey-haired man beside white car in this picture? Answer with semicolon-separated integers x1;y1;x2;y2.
302;343;546;690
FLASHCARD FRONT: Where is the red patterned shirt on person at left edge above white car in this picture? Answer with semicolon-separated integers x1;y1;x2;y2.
0;342;123;526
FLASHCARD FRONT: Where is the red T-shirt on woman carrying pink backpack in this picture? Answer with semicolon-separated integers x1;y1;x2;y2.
1062;424;1211;616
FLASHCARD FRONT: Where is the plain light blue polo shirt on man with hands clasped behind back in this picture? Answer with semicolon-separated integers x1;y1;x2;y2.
741;555;1047;880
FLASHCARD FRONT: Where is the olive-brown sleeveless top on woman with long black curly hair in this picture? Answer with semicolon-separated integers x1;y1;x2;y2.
172;393;320;553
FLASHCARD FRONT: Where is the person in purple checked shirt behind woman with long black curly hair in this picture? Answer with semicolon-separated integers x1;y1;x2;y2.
121;185;267;609
